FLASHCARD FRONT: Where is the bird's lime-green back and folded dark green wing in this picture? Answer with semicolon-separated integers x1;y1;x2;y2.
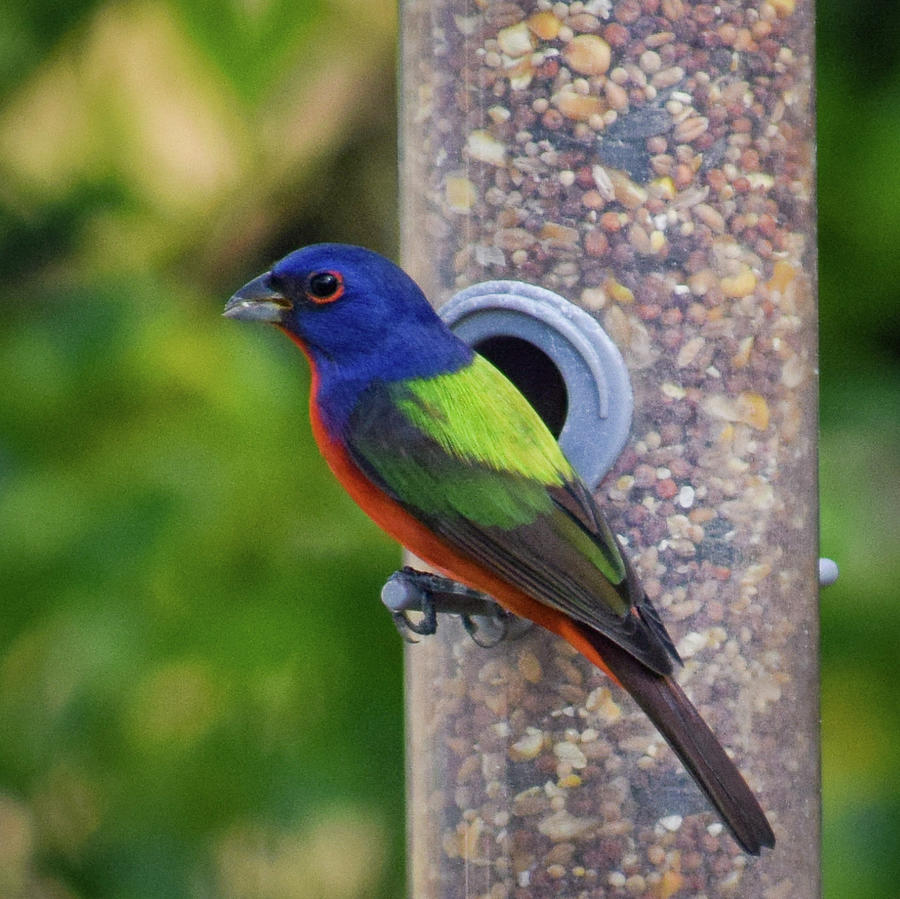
346;355;677;673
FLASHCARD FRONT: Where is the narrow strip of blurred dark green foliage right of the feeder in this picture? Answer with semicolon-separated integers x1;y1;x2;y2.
817;0;900;899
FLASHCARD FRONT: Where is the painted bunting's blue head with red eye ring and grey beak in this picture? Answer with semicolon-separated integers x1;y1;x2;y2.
224;243;472;428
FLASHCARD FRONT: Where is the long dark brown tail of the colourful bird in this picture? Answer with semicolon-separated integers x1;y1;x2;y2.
584;628;775;855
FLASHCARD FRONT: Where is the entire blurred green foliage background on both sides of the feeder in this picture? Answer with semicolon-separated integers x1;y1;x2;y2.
0;0;900;899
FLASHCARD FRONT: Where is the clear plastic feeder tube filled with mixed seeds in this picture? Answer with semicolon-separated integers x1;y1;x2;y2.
401;0;819;899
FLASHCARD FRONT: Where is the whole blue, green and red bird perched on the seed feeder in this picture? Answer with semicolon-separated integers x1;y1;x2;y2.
223;243;775;855
